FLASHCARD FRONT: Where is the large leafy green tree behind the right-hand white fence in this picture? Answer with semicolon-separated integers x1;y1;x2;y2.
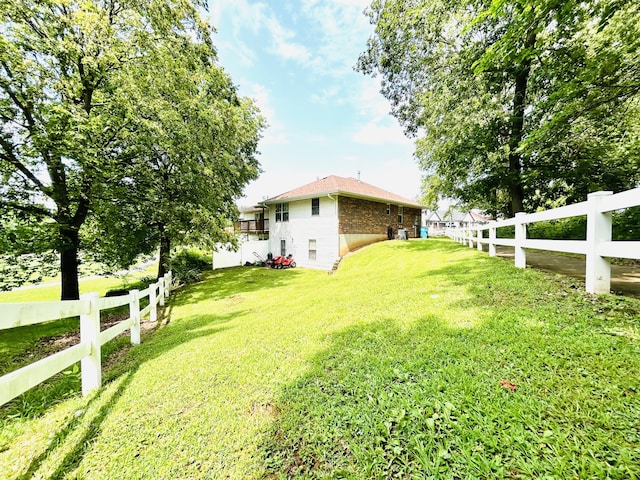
357;0;640;215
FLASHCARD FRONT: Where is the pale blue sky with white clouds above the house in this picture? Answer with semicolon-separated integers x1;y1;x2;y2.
208;0;421;206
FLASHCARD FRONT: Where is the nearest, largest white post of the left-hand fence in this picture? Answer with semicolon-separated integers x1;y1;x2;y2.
80;292;102;395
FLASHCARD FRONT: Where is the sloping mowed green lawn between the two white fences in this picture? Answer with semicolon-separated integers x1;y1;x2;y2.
0;239;640;479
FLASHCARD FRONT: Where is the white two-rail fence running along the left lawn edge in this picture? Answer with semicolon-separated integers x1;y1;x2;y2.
0;272;171;405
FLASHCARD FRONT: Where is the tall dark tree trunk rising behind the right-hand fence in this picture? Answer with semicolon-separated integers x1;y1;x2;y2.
508;31;536;217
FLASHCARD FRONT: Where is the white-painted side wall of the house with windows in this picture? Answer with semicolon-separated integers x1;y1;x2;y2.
269;196;339;270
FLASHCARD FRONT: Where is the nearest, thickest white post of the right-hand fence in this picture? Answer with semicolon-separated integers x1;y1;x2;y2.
585;191;613;293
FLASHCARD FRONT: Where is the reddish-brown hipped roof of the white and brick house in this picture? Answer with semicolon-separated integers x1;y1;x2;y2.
264;175;422;208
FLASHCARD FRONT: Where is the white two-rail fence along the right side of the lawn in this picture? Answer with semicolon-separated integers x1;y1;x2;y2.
447;188;640;293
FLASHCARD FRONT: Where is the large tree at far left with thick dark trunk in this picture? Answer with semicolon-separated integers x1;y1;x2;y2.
0;0;262;299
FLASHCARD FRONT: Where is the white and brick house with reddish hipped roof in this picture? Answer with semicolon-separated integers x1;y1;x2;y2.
263;176;422;269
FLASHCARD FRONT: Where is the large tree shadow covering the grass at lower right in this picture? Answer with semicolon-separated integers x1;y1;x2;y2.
261;266;640;478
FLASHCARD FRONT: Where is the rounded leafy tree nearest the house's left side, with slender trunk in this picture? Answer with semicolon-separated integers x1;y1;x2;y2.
85;38;264;277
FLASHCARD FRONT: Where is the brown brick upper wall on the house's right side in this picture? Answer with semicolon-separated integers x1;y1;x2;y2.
338;197;421;237
